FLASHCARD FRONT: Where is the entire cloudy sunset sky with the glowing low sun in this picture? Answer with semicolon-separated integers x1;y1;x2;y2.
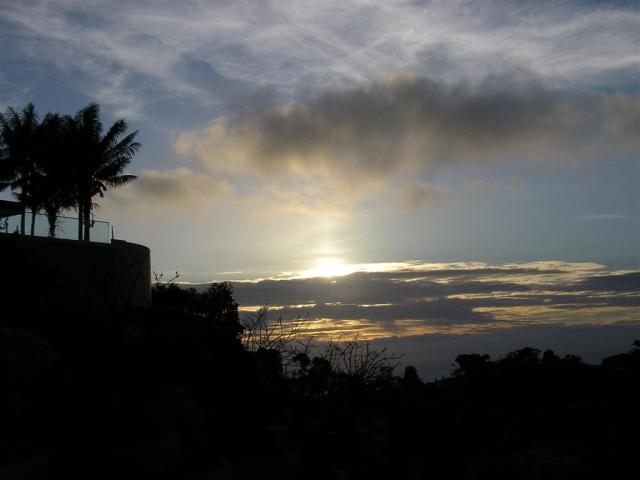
0;0;640;376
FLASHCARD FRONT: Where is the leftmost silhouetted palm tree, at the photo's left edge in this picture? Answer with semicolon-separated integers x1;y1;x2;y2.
0;103;43;235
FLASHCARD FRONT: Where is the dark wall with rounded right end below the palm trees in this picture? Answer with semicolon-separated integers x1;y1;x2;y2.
0;234;151;312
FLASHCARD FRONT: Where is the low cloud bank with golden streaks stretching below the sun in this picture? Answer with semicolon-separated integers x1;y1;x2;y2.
178;262;640;339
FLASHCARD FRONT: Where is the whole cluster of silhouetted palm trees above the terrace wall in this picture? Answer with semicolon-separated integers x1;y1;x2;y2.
0;103;141;241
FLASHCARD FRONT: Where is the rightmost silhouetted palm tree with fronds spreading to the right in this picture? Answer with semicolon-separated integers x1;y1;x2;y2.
66;103;141;241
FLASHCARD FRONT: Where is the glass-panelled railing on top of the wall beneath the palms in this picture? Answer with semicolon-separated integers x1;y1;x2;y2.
0;211;111;243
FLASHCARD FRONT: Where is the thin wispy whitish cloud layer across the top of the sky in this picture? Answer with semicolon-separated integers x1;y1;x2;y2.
0;0;640;117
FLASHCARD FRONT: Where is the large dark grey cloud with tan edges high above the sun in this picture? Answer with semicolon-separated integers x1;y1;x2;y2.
177;70;640;189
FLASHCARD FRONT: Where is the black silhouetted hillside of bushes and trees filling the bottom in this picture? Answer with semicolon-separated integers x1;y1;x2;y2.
0;272;640;479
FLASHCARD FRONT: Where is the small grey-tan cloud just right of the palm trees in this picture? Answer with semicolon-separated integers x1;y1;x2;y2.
103;168;232;215
